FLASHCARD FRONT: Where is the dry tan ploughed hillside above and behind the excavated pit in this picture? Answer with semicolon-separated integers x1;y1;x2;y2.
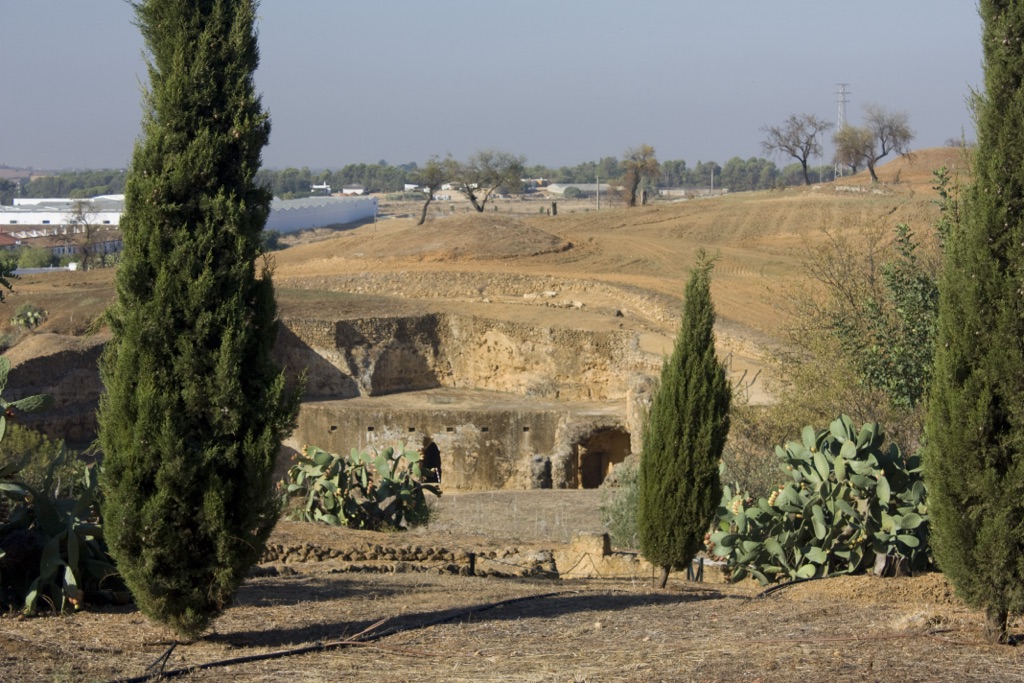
0;148;966;413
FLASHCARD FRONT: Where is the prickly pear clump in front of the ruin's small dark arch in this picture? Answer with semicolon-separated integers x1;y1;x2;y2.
285;446;441;529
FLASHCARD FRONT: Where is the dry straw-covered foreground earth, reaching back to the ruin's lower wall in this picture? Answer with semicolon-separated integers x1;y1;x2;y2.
0;490;1024;683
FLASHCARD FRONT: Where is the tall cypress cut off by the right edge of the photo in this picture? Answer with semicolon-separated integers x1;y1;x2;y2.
925;0;1024;642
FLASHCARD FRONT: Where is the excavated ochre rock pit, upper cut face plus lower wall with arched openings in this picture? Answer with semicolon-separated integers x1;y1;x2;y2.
276;313;660;490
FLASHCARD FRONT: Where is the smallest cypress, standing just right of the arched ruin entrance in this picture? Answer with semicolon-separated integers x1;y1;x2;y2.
637;250;732;588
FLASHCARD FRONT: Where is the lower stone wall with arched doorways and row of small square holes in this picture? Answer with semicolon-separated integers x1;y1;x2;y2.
287;389;630;490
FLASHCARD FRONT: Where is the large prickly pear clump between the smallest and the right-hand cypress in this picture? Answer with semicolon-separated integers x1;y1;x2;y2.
706;416;931;584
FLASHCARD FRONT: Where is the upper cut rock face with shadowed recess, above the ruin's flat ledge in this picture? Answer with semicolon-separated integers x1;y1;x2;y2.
275;313;652;400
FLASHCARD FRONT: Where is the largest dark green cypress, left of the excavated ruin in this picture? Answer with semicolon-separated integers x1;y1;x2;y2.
99;0;296;636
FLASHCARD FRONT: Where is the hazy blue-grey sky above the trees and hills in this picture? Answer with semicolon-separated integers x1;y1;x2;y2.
0;0;982;169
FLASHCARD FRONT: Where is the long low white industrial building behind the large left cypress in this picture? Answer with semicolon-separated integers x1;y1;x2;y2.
0;195;377;240
